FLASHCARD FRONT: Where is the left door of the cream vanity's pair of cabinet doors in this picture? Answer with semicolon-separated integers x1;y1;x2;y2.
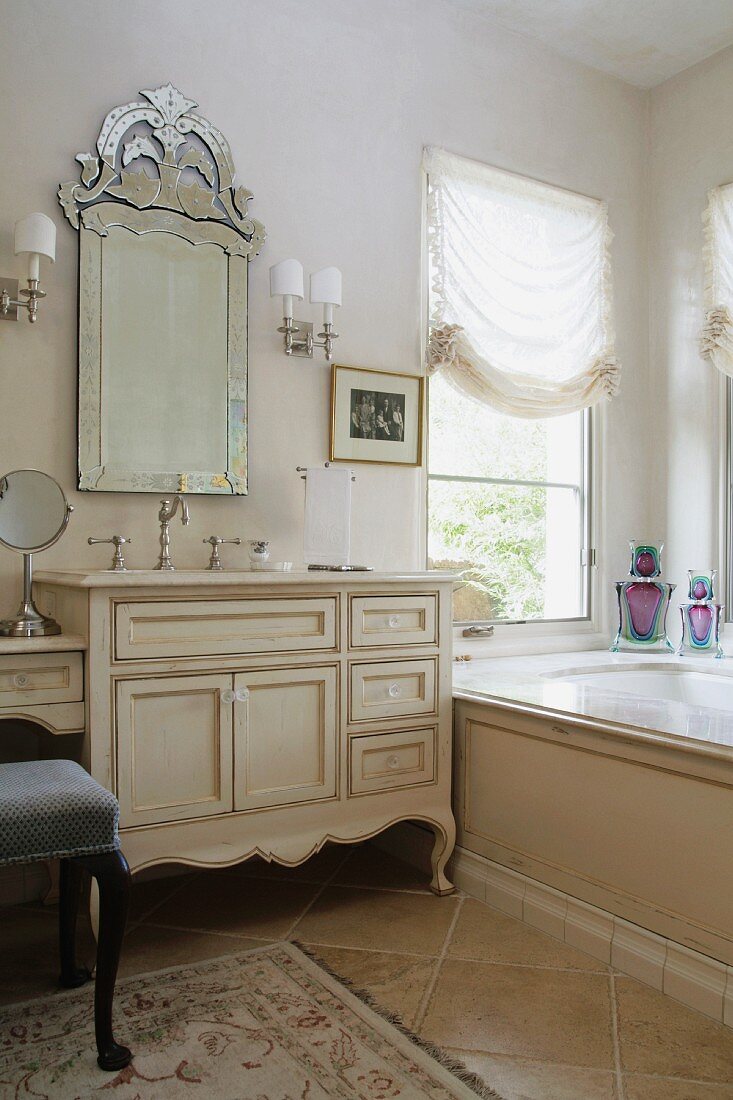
117;675;233;826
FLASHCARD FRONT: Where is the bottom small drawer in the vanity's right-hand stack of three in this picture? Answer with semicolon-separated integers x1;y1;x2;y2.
349;729;436;794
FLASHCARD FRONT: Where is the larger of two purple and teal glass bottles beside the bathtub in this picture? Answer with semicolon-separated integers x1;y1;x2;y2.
611;541;676;653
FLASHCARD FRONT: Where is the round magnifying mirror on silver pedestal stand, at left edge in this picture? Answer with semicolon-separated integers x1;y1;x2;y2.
0;470;74;638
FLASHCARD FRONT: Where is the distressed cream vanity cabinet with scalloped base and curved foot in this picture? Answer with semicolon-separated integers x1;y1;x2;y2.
35;571;455;893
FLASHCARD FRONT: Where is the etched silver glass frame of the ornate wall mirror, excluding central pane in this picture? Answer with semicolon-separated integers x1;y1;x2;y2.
58;84;265;494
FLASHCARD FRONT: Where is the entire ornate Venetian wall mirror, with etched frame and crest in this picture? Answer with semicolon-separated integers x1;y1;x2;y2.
58;84;264;494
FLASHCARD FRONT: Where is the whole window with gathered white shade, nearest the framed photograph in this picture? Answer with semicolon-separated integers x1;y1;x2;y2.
424;150;620;623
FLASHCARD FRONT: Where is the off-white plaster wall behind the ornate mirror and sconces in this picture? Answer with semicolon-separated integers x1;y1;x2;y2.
0;0;649;629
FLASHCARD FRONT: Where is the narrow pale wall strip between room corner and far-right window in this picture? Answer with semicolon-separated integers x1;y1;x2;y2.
647;50;733;620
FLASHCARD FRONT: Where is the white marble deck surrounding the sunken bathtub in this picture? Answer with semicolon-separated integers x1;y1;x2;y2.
453;650;733;761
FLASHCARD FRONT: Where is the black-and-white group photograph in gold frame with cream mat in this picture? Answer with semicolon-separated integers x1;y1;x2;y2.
331;364;423;466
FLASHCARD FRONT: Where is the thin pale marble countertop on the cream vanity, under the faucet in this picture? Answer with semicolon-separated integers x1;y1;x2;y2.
34;569;456;589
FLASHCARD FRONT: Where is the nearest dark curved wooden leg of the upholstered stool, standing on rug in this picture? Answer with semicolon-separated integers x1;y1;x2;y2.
77;851;132;1069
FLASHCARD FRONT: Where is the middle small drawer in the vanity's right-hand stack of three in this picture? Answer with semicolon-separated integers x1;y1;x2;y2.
349;657;437;722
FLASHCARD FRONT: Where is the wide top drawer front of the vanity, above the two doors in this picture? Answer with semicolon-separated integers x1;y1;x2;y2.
114;596;337;661
